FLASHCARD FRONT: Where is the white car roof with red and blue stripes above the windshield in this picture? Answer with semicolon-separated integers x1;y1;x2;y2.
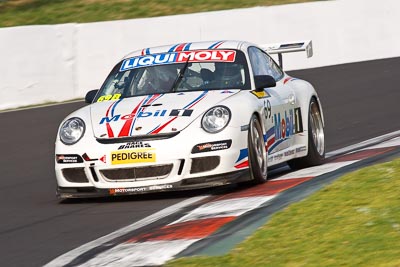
124;40;254;59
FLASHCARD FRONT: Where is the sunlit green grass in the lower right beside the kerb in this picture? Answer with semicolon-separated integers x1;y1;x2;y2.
167;159;400;267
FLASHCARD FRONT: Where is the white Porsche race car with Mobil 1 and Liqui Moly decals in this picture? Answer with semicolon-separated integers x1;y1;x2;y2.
55;41;325;198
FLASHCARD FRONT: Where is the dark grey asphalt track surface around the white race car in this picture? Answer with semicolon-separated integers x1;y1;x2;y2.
0;58;400;266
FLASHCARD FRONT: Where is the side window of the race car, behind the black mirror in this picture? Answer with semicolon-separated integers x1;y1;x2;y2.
249;47;283;81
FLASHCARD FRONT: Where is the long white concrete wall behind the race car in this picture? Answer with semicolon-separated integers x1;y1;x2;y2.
0;0;400;109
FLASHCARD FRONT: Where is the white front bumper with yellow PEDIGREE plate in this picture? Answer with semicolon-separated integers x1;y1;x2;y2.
55;124;250;198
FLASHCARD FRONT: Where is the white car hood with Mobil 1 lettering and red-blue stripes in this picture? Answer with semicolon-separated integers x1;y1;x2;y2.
90;89;240;139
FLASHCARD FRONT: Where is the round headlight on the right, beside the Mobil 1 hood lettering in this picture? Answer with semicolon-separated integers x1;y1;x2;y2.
201;106;231;133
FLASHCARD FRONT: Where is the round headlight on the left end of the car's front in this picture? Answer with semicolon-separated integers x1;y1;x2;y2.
59;118;85;145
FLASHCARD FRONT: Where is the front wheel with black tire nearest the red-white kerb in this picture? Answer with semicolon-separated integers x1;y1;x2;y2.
247;115;267;184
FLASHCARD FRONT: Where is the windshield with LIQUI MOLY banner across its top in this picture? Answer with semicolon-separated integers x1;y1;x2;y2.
95;50;250;102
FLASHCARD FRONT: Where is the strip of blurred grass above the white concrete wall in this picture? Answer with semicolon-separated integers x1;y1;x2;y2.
0;0;316;27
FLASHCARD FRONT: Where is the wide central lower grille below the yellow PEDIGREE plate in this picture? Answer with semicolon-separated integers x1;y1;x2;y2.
100;164;173;181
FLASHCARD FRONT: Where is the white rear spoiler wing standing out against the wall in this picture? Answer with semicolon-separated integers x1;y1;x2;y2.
260;40;313;68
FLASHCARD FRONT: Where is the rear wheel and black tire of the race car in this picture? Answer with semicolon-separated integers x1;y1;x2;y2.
288;98;325;170
